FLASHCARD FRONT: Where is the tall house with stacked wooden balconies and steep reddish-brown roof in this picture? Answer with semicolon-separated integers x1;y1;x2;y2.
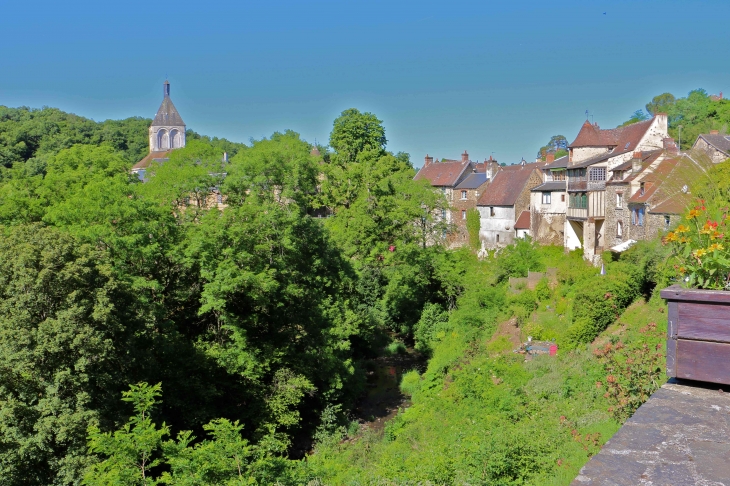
565;113;668;263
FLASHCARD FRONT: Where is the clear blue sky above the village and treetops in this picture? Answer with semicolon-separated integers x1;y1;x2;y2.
0;0;730;166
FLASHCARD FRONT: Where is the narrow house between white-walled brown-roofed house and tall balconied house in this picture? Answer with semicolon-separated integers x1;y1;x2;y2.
529;154;568;246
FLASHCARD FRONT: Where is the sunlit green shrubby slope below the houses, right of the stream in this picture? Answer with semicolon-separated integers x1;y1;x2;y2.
309;242;666;485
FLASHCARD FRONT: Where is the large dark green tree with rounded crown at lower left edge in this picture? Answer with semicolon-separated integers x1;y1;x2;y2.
0;225;143;485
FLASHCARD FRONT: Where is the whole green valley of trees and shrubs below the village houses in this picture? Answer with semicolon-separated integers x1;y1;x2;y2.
0;93;712;485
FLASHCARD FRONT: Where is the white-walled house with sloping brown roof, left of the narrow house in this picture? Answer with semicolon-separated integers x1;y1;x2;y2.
477;161;543;248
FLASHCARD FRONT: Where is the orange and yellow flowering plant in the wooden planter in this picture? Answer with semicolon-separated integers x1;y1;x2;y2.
662;199;730;290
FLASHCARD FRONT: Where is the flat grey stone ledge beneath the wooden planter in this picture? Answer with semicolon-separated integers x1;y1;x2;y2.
571;381;730;486
